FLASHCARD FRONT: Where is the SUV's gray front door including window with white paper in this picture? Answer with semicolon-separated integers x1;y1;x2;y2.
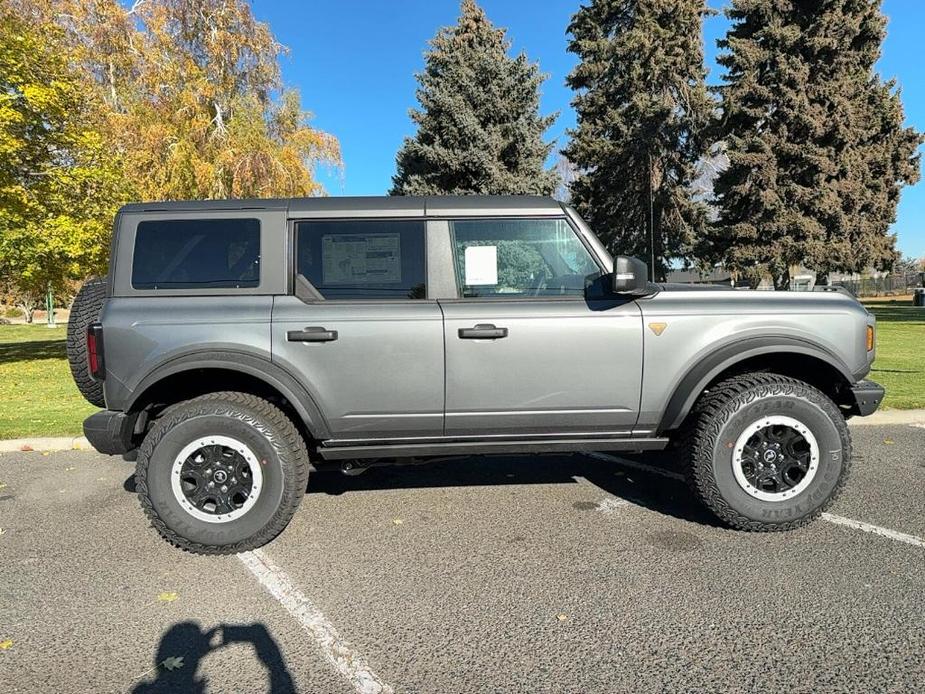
440;218;642;436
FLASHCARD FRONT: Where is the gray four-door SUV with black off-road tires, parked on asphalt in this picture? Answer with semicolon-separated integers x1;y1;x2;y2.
69;197;883;554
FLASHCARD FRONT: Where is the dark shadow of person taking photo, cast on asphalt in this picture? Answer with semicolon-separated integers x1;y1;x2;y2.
132;621;296;694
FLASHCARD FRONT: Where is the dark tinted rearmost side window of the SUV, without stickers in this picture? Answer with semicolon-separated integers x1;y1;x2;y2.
132;219;260;289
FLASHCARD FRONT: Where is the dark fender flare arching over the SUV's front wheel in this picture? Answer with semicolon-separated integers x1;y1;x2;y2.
658;335;858;432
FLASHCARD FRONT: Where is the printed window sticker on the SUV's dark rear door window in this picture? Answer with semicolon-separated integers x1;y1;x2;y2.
321;234;401;285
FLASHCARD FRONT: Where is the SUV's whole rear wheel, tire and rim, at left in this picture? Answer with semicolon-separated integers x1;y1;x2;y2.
135;393;309;554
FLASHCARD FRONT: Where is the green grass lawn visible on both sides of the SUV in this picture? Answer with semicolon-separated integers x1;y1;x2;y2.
0;303;925;439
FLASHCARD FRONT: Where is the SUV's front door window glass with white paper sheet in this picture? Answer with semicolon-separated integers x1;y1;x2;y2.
450;219;601;297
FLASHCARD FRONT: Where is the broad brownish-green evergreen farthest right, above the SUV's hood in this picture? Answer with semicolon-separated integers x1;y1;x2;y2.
700;0;921;289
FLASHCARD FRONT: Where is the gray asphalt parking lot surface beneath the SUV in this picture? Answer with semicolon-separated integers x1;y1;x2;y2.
0;426;925;692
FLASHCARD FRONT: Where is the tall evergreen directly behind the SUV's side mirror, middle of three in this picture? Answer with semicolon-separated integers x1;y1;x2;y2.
564;0;714;278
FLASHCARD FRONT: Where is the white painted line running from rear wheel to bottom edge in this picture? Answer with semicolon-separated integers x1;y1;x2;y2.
238;549;393;694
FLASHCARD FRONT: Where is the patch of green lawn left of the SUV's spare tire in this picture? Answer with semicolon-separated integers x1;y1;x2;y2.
0;325;96;439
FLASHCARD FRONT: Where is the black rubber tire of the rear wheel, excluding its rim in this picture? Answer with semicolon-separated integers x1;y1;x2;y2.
135;392;310;554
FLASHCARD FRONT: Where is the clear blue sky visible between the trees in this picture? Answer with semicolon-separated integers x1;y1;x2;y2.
253;0;925;257
